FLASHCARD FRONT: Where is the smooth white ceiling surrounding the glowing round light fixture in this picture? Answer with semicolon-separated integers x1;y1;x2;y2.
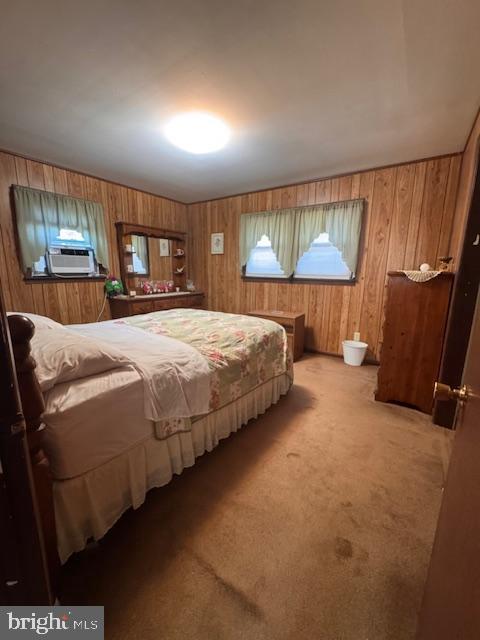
0;0;480;202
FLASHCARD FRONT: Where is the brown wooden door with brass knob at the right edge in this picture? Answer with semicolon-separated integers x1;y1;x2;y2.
417;288;480;640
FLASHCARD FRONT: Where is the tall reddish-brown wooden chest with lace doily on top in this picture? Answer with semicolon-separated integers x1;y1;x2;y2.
375;271;454;413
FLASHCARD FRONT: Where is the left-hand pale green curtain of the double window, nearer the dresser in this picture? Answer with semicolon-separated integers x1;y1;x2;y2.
240;209;296;276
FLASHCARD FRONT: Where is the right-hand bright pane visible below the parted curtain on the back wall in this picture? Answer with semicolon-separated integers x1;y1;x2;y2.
294;233;352;280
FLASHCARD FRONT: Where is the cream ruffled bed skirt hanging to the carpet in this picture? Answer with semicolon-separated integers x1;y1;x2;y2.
53;373;292;563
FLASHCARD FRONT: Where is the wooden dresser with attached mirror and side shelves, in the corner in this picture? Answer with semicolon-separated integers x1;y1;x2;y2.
109;222;204;318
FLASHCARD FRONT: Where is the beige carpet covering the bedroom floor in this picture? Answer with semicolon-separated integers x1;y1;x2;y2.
58;355;451;640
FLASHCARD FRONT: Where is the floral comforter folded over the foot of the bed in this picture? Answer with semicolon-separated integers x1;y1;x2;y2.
121;309;293;430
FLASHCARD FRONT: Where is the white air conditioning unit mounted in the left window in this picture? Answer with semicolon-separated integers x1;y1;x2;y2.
46;241;97;278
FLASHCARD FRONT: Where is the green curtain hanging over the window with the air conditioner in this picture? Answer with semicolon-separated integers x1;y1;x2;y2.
13;186;108;271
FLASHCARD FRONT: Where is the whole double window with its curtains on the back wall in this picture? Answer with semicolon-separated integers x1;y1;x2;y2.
240;200;364;281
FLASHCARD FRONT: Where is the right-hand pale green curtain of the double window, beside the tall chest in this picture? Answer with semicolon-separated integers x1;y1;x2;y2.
296;200;363;273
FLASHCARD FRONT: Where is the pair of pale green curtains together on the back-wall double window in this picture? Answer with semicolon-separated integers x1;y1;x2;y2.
240;200;364;276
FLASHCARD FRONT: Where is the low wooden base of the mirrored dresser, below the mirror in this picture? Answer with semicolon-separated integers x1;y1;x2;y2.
110;291;204;319
